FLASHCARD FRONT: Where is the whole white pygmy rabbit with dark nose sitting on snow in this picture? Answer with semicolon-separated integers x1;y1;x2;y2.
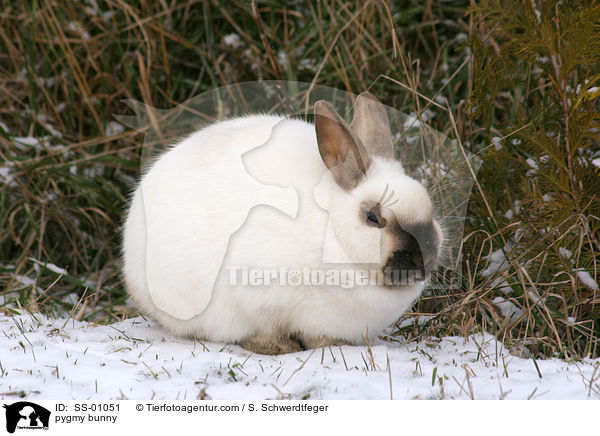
122;92;444;354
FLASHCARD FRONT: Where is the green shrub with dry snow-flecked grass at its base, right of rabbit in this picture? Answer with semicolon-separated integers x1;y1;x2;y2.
454;0;600;357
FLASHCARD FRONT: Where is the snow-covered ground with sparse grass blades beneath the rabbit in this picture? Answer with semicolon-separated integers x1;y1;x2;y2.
0;314;600;400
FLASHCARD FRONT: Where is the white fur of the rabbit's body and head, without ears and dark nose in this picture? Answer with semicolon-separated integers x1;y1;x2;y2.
123;115;439;343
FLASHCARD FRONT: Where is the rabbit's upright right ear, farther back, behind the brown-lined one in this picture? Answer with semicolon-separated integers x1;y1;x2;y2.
352;91;394;158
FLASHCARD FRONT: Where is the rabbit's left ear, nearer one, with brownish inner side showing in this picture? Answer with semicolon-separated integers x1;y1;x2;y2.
315;100;371;190
